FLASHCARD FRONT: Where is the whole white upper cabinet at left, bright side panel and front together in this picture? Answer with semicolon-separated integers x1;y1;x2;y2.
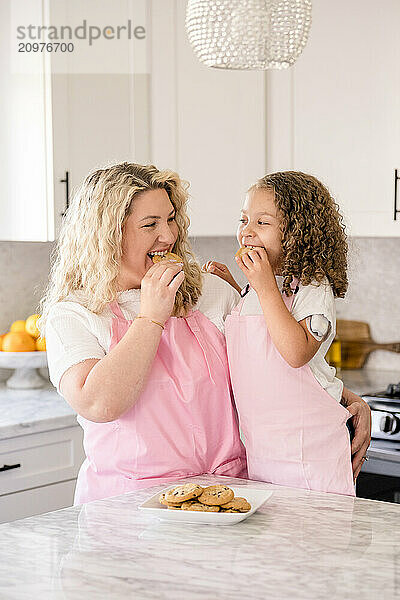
0;0;150;241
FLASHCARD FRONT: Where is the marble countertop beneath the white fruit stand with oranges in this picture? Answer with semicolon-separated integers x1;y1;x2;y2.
0;382;77;440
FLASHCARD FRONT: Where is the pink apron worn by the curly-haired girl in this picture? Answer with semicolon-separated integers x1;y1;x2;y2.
225;282;355;496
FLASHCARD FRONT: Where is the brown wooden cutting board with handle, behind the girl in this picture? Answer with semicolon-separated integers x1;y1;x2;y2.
336;319;400;369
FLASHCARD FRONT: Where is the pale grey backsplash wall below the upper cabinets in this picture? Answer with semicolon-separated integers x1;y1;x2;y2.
0;237;400;379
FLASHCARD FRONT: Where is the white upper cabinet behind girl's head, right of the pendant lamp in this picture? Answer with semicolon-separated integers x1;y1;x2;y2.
267;0;400;236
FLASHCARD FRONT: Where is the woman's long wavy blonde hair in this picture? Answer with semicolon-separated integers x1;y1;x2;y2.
39;162;202;335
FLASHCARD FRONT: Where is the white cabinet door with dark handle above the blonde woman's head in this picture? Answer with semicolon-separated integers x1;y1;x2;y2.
49;74;134;239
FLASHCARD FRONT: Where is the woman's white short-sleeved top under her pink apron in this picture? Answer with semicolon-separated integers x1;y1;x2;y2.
45;273;240;392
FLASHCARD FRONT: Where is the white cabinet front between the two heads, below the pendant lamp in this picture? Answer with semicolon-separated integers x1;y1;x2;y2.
151;0;266;236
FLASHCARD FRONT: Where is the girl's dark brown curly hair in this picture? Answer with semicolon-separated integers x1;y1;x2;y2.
249;171;348;298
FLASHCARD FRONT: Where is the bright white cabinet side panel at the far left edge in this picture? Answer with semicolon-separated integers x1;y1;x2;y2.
0;0;51;241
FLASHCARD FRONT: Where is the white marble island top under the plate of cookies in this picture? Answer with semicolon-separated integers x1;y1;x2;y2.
0;476;400;600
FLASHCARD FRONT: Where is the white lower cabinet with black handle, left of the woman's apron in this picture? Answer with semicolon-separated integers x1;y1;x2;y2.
0;426;85;523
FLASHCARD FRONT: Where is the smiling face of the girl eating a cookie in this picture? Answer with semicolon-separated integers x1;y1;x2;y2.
237;189;282;274
